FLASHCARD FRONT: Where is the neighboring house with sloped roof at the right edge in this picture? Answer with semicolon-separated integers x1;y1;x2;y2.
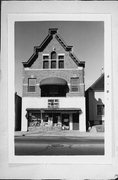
85;74;105;128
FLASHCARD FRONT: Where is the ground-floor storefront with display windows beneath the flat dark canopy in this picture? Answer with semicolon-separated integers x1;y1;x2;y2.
26;108;81;130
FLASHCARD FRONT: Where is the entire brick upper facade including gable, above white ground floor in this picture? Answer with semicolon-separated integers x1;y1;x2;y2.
23;28;84;97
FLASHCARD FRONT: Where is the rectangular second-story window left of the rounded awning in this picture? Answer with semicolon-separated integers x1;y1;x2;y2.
28;78;36;92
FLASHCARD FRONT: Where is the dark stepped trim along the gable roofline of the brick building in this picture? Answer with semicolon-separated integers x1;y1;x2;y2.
23;28;85;67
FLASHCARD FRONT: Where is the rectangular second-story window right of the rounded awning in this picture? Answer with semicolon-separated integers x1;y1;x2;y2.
70;77;79;92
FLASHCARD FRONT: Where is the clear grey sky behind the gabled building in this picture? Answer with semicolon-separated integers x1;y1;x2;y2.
15;21;104;96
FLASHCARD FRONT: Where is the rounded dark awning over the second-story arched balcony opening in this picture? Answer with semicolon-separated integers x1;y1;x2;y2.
40;77;67;86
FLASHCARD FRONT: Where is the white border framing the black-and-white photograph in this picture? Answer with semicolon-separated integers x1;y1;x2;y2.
8;13;113;164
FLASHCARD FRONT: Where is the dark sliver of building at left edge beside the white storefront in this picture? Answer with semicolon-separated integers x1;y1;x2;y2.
15;93;22;131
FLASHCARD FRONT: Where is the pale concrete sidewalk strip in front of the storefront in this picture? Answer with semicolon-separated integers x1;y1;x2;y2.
15;130;104;138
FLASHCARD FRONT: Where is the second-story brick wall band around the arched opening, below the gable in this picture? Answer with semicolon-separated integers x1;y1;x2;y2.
23;69;84;97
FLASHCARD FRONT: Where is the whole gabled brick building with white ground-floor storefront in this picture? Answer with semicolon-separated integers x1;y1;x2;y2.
22;28;86;131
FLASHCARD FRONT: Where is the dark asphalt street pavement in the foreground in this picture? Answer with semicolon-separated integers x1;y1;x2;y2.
15;132;104;156
